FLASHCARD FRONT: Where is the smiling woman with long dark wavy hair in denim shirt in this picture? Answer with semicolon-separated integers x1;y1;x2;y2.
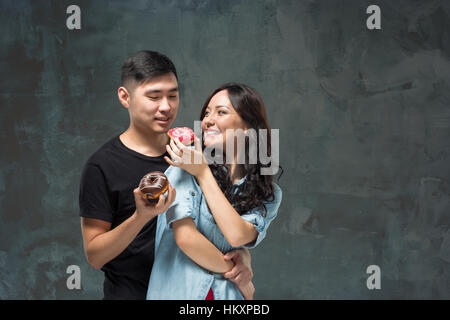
147;83;282;300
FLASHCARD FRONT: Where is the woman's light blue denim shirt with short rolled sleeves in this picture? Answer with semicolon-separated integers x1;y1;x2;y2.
147;166;282;300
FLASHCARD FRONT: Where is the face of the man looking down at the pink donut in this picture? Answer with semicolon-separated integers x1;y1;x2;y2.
129;73;180;133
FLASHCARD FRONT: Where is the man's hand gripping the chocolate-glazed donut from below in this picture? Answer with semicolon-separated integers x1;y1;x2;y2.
133;183;176;222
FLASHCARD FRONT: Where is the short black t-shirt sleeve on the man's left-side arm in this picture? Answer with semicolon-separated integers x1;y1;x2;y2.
79;162;114;222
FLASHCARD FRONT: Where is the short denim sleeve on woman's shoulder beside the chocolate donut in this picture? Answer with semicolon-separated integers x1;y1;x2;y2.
161;167;200;228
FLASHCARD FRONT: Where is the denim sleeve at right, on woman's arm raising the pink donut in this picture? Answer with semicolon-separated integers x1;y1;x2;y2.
241;183;282;249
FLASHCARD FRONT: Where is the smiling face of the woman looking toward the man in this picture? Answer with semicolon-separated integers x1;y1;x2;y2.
202;90;248;150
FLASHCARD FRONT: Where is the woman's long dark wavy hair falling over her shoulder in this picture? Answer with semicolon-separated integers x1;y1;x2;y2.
200;83;281;215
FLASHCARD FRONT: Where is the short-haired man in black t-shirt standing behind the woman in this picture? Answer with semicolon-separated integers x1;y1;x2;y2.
79;51;253;299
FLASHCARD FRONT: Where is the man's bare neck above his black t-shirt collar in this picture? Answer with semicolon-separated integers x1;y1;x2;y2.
119;126;169;157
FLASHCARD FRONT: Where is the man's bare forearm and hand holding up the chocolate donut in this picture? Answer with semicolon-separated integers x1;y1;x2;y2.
81;185;175;269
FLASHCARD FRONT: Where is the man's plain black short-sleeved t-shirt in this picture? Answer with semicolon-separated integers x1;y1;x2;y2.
79;136;169;299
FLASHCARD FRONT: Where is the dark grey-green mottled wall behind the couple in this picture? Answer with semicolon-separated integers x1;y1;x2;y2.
0;0;450;299
